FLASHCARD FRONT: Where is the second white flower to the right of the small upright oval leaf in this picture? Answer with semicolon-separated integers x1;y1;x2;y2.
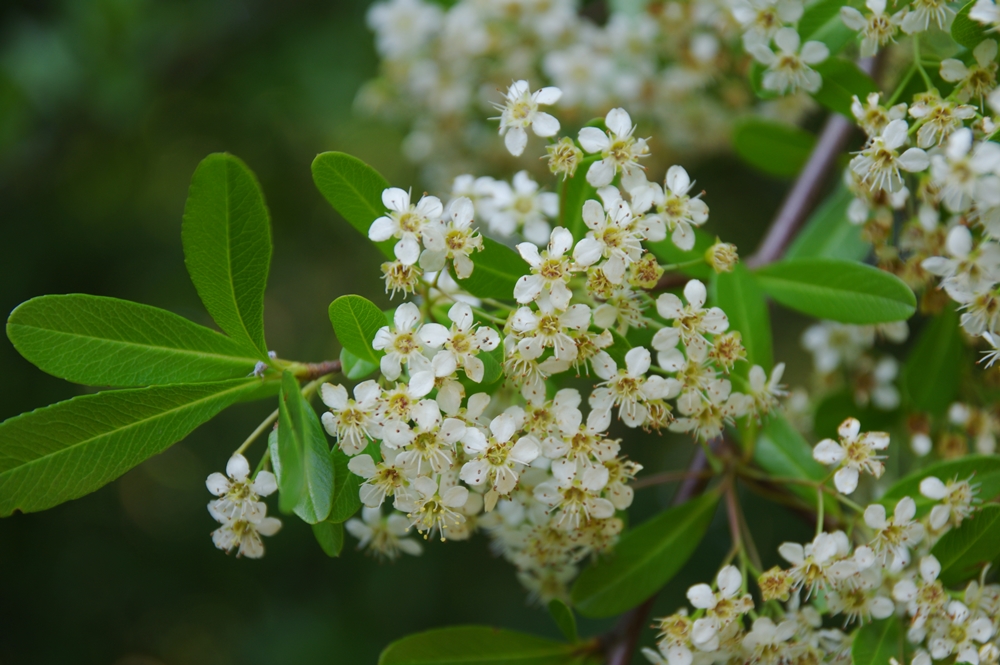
420;302;500;383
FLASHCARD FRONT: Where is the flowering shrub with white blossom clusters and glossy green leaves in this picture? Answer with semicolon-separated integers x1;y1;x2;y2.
0;0;1000;665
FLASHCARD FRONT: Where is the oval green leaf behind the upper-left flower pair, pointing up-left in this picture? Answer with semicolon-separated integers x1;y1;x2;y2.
312;152;395;259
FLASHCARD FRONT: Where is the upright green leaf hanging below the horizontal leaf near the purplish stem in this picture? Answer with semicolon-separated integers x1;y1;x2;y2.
715;263;774;376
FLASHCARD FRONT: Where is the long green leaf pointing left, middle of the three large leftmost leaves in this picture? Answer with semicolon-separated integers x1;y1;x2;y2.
7;294;257;386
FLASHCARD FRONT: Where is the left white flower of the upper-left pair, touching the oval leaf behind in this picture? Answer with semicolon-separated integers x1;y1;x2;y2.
368;187;445;266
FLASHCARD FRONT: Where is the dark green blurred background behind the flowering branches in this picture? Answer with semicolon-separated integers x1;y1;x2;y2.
0;0;808;665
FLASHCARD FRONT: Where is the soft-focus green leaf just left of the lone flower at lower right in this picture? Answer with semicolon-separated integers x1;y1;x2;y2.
753;415;837;514
